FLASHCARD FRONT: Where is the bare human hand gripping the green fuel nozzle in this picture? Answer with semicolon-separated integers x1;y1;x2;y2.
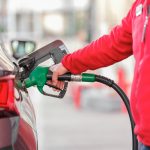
49;63;68;89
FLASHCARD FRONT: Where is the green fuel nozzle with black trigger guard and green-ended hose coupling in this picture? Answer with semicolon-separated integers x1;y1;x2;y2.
16;66;96;98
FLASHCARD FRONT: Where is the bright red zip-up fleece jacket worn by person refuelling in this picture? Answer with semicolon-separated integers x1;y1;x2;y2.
62;0;150;146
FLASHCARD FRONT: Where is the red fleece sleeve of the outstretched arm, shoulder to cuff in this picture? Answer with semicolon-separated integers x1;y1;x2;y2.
62;6;132;74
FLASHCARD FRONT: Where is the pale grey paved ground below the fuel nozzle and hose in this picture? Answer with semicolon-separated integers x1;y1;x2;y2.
30;90;131;150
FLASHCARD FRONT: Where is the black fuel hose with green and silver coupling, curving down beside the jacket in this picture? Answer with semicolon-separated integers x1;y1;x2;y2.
47;73;138;150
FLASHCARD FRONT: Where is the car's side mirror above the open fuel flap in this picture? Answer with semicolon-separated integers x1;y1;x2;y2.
11;40;36;59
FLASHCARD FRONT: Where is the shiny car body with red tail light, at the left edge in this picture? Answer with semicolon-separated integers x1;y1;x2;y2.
0;42;38;150
